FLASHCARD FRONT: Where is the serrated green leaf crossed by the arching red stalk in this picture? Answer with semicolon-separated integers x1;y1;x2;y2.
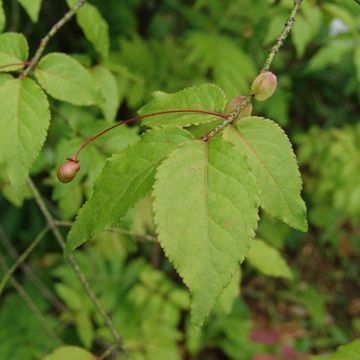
139;84;226;127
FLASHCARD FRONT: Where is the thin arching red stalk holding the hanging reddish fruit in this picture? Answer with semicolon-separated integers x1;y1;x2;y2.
70;109;228;161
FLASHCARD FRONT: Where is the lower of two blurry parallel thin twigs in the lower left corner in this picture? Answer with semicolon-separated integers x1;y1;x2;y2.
0;253;63;344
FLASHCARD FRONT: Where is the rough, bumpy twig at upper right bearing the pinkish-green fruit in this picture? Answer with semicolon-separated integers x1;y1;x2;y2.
201;0;302;141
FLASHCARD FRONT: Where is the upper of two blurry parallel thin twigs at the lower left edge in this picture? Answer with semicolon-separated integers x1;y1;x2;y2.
0;225;66;313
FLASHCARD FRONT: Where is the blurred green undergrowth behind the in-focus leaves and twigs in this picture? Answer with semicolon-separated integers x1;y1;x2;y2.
0;0;360;360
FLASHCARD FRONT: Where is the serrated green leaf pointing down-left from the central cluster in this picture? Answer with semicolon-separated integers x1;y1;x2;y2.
67;128;192;252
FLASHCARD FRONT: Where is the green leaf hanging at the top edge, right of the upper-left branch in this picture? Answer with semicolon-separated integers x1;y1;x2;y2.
67;0;110;57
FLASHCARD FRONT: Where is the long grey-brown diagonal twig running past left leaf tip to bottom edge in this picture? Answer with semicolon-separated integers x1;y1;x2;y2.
28;178;127;354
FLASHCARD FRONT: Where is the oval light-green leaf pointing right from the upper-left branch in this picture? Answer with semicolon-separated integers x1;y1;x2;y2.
35;53;100;105
